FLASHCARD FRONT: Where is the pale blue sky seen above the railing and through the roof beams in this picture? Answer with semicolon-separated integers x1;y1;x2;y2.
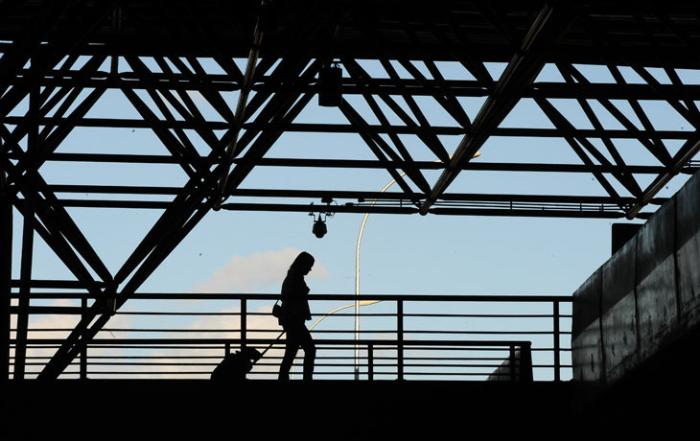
8;60;699;378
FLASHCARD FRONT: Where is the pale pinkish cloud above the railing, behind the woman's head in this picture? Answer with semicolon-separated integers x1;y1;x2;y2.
192;248;328;292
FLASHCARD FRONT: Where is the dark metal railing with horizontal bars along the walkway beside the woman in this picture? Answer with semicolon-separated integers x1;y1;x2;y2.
10;292;573;381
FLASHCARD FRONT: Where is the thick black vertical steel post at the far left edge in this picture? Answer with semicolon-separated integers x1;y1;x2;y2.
0;168;12;385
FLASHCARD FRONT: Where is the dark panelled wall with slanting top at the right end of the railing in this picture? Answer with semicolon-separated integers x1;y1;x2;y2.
572;174;700;382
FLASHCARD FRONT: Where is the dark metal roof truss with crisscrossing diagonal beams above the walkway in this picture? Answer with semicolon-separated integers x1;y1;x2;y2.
0;0;700;378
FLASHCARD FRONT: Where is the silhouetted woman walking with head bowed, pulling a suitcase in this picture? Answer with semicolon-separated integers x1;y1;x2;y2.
279;251;316;380
